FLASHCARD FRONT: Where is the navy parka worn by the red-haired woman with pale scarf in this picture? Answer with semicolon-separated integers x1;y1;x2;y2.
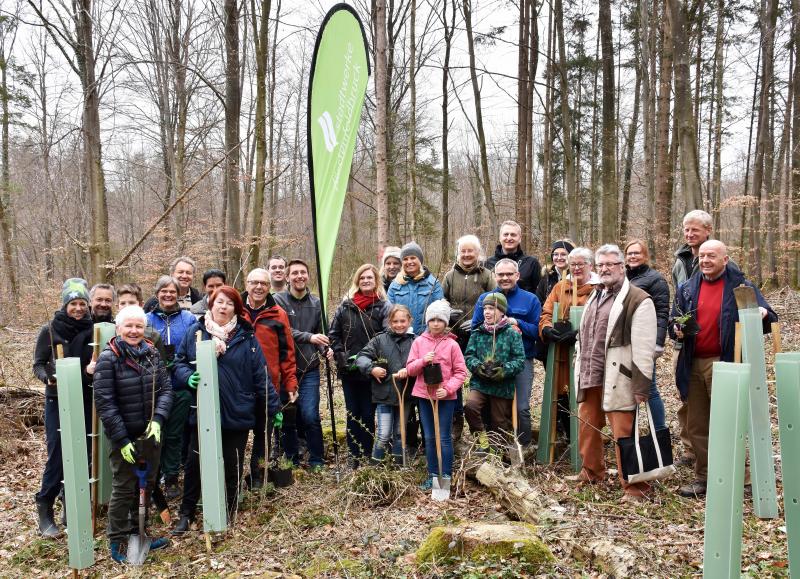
173;314;280;430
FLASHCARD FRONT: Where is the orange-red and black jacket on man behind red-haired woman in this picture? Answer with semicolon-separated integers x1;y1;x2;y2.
242;292;297;392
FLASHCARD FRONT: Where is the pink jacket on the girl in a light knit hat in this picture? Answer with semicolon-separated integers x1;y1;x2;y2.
406;330;467;400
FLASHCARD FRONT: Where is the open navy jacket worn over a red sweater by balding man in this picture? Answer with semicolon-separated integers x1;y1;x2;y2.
669;263;778;400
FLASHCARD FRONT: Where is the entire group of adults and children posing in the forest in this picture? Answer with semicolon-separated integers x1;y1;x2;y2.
34;210;777;561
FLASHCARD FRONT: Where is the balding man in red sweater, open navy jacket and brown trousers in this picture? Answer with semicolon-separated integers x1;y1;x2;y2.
670;240;778;497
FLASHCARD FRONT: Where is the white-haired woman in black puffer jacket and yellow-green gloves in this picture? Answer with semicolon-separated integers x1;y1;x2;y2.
94;306;173;563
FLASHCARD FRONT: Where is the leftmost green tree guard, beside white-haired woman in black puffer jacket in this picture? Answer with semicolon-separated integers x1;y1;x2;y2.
56;358;94;569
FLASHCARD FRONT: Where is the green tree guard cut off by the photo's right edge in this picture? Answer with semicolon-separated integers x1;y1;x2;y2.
775;352;800;577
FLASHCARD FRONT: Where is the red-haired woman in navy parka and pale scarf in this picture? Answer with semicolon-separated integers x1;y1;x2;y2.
174;286;283;533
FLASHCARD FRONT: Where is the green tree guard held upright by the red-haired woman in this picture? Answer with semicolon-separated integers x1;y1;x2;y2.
197;340;228;533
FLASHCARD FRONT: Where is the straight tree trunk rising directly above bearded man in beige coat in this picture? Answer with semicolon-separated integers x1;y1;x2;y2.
598;0;619;243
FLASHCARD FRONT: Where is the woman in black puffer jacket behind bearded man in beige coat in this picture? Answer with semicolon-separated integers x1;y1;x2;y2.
625;239;670;430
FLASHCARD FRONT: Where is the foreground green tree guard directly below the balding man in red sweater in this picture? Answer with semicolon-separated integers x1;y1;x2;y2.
703;362;751;579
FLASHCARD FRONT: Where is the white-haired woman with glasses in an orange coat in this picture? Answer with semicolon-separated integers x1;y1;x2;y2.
539;247;597;437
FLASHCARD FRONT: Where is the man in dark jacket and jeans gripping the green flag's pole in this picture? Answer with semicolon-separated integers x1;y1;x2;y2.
275;259;333;471
